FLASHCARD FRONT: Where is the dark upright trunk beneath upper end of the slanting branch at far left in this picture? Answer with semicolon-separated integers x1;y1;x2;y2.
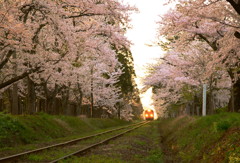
26;77;36;114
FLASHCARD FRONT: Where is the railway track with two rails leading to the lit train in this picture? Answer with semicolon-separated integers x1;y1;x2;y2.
0;122;148;163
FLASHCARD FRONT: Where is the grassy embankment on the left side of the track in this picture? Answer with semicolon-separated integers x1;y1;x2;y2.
0;113;130;152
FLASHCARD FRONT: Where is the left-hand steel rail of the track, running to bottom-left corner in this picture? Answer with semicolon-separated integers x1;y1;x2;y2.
0;122;145;162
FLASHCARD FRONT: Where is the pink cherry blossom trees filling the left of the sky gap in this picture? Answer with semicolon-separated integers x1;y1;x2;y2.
0;0;141;119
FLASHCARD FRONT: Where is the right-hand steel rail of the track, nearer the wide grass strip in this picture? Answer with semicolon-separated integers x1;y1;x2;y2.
49;121;149;163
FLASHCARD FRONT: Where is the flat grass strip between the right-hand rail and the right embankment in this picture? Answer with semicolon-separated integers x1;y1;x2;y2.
61;121;163;163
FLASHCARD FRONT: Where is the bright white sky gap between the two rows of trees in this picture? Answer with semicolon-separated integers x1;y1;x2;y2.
124;0;172;109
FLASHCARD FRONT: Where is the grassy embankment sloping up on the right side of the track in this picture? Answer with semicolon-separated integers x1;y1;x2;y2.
160;113;240;163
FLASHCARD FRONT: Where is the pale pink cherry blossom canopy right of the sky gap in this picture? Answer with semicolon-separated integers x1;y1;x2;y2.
146;0;239;116
